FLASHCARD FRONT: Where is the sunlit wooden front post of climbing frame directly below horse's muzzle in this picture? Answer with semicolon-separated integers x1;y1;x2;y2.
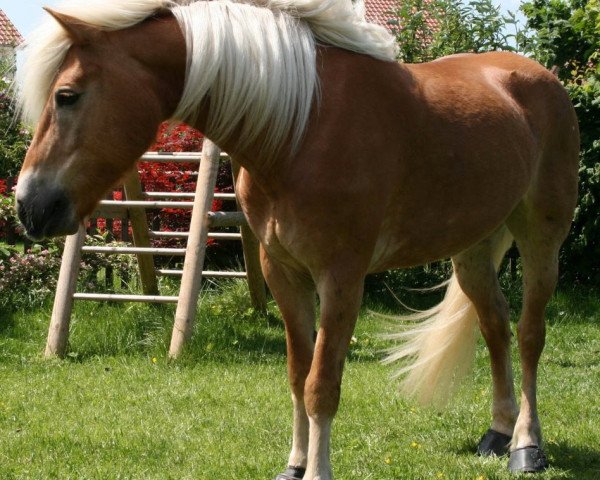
44;224;85;357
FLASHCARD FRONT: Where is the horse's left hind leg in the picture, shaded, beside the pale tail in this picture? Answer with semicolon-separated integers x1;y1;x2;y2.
452;226;518;455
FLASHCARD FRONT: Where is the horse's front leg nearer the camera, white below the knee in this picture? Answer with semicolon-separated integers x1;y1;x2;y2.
304;272;364;480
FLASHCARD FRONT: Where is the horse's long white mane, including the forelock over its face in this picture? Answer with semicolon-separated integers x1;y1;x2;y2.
17;0;396;156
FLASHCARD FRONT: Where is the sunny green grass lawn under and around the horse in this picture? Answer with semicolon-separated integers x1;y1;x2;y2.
0;283;600;480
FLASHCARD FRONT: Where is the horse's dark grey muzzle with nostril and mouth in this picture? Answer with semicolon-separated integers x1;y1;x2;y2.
16;177;79;240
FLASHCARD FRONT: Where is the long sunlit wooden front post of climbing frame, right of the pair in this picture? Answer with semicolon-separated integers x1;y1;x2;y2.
169;139;221;358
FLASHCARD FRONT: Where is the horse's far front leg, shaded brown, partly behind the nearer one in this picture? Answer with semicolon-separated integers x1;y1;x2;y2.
261;250;315;480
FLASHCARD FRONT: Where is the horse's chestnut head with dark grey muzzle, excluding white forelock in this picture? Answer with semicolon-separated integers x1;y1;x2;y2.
16;7;185;239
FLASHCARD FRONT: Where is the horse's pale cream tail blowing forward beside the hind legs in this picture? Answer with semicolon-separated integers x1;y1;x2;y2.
384;232;512;407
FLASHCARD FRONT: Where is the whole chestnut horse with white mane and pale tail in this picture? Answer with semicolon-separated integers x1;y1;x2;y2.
16;0;579;480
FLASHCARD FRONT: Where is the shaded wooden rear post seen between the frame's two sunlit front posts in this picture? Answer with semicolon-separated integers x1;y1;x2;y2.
121;168;158;295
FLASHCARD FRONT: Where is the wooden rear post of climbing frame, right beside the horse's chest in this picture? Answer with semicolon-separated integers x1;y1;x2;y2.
231;160;267;313
